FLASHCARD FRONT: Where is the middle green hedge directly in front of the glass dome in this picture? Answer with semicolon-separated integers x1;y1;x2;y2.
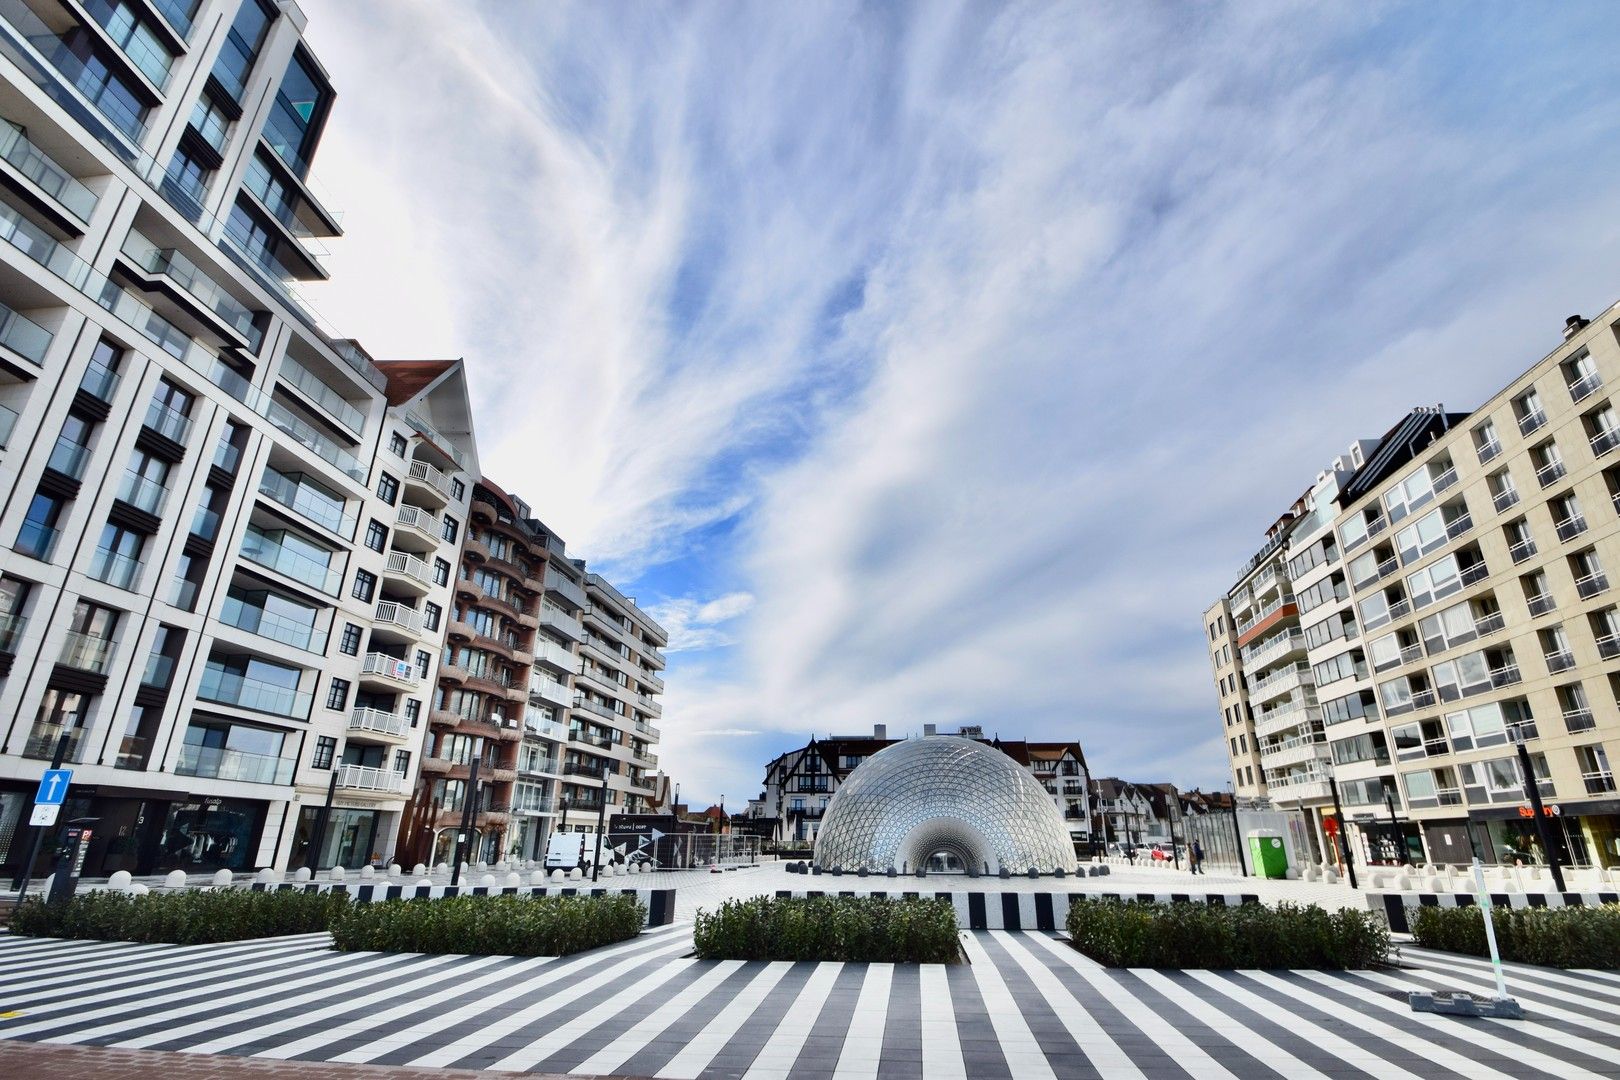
692;897;961;963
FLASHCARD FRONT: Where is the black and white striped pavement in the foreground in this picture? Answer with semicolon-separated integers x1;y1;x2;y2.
0;923;1620;1080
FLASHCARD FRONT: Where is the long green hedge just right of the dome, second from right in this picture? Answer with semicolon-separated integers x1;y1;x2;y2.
1068;900;1390;970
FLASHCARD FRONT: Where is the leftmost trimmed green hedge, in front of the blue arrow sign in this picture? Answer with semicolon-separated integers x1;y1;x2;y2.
11;889;348;946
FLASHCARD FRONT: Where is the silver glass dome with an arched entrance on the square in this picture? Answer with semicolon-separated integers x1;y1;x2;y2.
815;735;1076;874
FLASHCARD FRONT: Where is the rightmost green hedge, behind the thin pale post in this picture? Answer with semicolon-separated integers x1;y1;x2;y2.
1406;904;1620;970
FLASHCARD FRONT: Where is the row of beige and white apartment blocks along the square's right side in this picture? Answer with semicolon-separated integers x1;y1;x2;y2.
1204;308;1620;866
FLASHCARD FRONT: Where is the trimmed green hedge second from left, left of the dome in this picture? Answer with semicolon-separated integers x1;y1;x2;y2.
332;894;646;957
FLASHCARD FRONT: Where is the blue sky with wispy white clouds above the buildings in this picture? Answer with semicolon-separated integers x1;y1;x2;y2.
305;0;1620;808
